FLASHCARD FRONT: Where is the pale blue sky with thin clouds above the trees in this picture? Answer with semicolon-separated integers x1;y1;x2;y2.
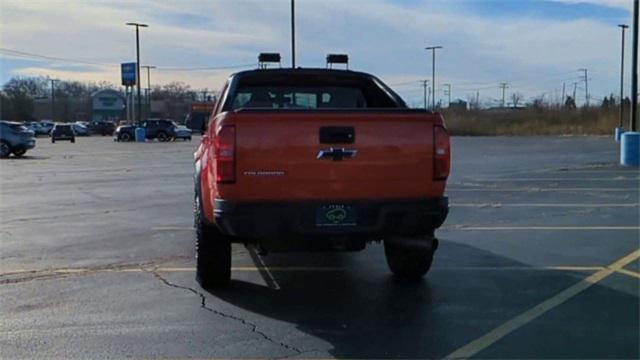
0;0;632;105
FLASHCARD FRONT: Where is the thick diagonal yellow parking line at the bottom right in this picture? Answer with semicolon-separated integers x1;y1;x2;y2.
445;250;640;359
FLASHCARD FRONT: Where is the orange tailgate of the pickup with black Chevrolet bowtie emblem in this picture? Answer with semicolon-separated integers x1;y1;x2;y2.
218;110;446;201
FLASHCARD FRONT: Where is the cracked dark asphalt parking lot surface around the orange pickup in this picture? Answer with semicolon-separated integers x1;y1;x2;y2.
0;137;640;359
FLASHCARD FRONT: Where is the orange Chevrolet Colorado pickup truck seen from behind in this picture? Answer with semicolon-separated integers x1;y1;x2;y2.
194;68;450;288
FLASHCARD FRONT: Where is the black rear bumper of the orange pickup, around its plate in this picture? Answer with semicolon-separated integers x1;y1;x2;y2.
214;197;449;239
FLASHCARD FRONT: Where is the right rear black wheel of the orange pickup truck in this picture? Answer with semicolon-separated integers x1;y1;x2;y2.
384;237;438;281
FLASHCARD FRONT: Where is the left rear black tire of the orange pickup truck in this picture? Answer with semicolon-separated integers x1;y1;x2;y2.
193;196;231;289
